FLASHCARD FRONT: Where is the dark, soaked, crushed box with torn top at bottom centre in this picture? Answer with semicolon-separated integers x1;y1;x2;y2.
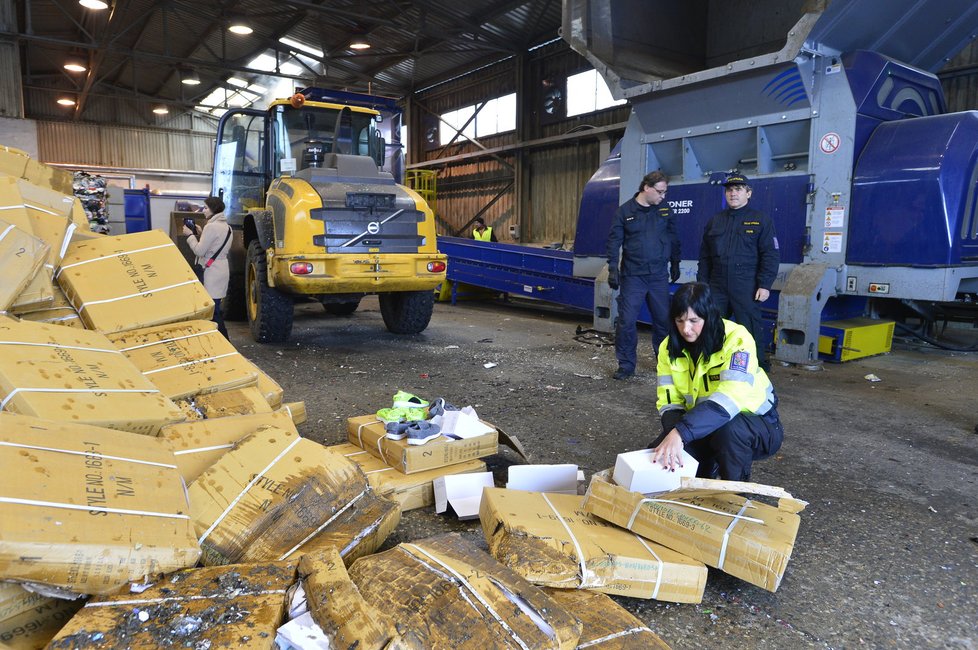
349;534;581;648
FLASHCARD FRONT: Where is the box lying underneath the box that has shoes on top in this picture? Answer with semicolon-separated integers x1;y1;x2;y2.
327;442;486;512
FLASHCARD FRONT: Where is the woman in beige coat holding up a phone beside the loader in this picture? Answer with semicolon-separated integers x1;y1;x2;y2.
183;196;231;338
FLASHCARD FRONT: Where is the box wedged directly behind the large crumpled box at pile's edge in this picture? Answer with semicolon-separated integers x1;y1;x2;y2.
160;411;299;485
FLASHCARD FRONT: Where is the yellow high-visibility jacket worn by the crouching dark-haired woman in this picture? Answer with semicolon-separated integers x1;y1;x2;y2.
656;320;775;443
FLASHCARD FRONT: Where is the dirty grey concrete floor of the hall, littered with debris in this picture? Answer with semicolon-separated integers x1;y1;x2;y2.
229;298;978;649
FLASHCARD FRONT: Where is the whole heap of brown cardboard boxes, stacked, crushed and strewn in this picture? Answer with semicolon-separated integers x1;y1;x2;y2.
0;147;803;649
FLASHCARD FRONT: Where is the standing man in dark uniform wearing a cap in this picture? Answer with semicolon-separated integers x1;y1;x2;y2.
696;173;781;371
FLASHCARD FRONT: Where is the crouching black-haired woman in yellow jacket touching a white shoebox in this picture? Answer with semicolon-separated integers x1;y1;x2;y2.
652;282;784;481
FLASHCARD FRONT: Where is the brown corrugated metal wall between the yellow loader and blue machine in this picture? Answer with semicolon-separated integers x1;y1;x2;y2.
409;42;629;247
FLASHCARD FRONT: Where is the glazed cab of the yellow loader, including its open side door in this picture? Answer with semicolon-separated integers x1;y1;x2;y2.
211;100;386;219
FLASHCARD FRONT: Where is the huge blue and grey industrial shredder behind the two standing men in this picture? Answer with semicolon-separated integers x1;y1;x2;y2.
440;0;978;364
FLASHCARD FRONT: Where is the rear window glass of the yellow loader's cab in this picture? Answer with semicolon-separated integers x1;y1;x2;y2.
273;104;383;175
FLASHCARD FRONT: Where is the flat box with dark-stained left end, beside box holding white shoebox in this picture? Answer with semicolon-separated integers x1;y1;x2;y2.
479;488;706;603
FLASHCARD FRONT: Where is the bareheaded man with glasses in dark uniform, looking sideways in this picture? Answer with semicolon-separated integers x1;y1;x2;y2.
608;171;679;380
